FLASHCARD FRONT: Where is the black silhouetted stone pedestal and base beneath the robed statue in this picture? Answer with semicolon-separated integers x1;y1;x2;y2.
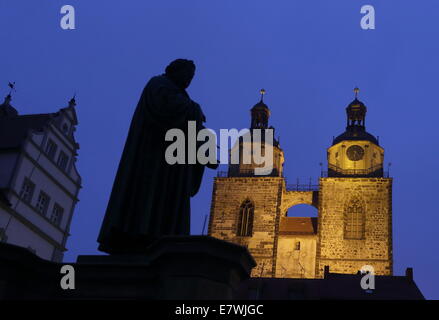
0;236;255;300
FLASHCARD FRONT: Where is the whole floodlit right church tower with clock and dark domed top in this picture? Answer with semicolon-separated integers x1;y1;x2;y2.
316;88;393;277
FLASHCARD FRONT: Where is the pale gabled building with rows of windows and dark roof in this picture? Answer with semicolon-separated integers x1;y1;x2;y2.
0;94;81;262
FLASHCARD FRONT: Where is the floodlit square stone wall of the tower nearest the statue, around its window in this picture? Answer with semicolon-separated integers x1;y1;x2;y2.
209;177;284;277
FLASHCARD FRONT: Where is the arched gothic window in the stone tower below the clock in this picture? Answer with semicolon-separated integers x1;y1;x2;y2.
344;198;365;239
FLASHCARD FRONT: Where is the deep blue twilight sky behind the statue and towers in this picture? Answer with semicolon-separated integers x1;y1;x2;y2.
0;0;439;299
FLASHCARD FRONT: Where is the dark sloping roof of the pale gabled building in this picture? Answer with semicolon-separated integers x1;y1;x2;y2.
0;113;52;149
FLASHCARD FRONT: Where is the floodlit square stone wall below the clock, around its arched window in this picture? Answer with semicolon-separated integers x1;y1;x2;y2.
316;178;393;277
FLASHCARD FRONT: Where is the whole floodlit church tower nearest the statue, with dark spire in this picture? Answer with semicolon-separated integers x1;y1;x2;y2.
209;90;285;277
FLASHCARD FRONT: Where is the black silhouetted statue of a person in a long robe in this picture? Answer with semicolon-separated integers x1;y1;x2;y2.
98;59;217;254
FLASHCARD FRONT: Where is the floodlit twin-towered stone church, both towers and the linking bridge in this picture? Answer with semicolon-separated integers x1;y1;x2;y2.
209;91;393;278
